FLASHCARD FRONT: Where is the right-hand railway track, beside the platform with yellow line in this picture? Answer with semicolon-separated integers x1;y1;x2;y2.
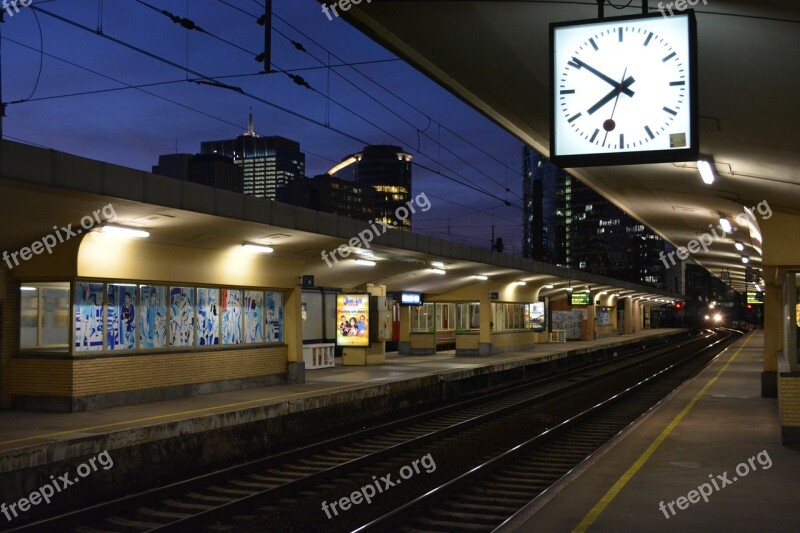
355;326;744;533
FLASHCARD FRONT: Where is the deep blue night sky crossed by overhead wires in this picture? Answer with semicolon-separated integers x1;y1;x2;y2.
0;0;522;254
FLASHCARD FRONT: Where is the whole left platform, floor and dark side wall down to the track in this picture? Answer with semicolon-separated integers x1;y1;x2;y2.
0;329;688;510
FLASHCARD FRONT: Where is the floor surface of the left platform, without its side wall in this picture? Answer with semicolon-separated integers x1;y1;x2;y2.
0;329;681;456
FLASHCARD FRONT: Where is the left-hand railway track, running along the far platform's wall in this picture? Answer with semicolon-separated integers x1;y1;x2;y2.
7;330;724;533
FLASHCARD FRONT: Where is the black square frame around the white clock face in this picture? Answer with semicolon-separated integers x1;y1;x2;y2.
550;9;700;168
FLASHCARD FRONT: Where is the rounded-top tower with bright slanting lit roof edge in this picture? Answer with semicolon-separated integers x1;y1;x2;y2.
327;145;412;231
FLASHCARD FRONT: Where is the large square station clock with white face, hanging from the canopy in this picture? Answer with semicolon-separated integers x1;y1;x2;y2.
550;11;699;167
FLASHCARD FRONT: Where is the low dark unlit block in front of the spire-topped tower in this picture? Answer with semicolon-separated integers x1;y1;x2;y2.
153;154;244;193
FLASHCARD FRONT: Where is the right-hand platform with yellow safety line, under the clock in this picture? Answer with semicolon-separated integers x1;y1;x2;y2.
502;330;800;532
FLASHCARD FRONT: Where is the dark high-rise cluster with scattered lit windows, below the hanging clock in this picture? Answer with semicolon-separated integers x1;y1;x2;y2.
523;146;666;289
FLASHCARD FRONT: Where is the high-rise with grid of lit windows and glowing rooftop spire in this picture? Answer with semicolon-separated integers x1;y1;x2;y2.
200;113;306;200
